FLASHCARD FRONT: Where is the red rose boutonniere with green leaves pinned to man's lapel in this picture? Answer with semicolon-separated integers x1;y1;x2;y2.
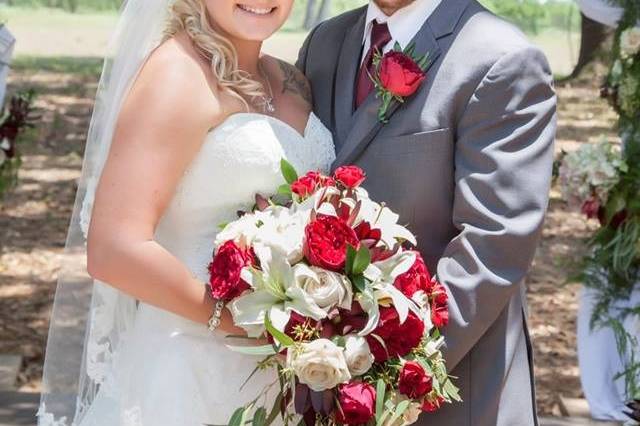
370;42;429;123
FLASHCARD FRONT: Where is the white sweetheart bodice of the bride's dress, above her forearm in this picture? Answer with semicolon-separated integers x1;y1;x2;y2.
156;113;335;279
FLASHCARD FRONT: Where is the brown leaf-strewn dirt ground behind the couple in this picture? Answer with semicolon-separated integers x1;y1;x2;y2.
0;60;614;414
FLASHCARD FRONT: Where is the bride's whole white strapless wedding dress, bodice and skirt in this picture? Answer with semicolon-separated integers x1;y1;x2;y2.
80;113;335;426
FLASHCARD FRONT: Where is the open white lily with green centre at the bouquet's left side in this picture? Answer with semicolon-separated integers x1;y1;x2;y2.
228;245;327;337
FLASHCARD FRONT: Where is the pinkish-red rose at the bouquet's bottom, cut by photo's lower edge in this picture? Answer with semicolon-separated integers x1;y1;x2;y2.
336;382;376;425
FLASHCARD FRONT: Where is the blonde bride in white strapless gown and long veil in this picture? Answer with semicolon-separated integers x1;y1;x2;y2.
38;0;334;426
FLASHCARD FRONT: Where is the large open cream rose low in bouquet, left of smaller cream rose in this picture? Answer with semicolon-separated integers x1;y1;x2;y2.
287;339;351;392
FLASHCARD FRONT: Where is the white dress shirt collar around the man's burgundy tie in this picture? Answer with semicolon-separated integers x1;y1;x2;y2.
360;0;442;62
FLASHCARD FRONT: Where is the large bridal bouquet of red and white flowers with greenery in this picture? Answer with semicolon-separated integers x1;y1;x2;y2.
209;160;460;426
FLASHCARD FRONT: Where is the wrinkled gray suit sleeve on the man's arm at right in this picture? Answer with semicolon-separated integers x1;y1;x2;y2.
437;47;556;369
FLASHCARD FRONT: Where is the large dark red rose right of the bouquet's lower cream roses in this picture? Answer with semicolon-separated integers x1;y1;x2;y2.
367;307;424;362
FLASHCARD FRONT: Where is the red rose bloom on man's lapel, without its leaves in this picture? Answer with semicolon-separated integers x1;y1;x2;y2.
380;51;426;97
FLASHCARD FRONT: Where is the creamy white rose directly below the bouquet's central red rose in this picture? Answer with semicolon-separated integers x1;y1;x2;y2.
293;263;353;312
